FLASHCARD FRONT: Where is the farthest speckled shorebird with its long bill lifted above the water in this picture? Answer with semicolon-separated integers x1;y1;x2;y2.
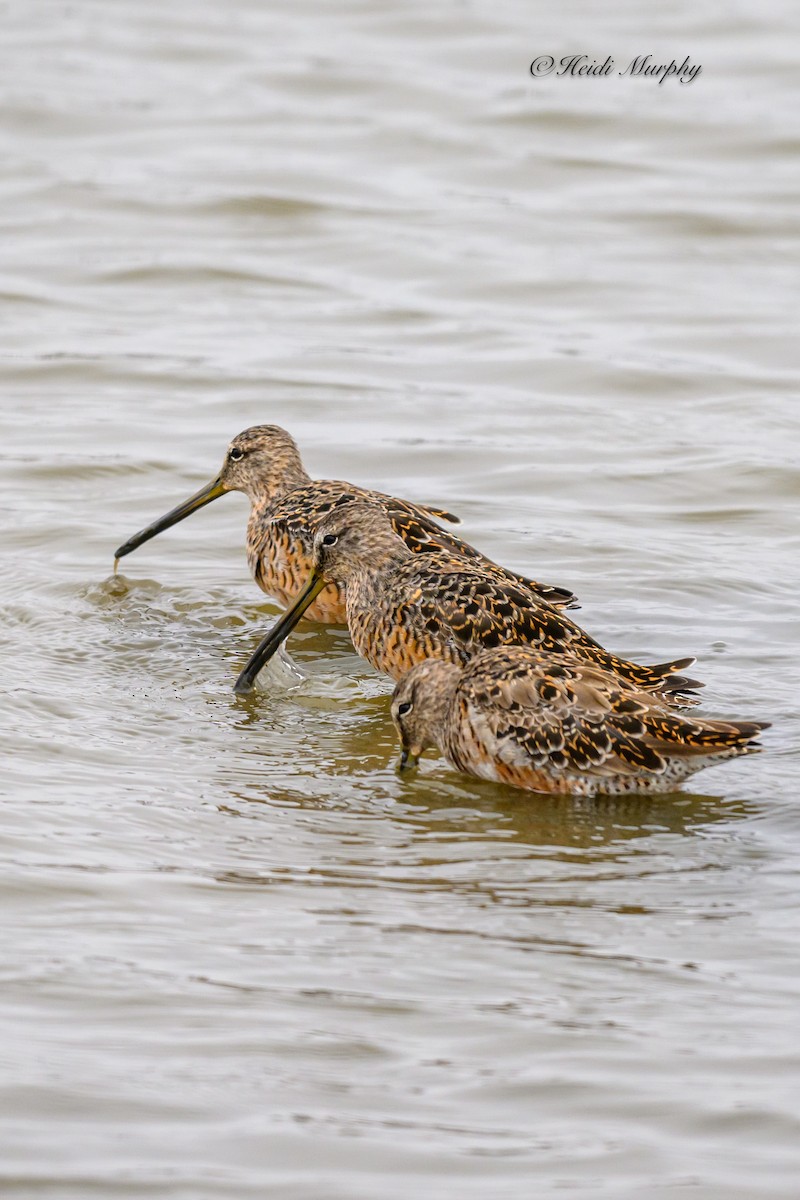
115;425;577;624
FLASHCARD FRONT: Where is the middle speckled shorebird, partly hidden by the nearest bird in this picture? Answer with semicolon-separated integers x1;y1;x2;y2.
235;502;702;703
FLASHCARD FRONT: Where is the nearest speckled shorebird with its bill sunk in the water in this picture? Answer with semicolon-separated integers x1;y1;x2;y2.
391;646;769;796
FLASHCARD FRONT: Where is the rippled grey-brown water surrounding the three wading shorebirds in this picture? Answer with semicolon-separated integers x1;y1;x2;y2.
0;0;800;1200
